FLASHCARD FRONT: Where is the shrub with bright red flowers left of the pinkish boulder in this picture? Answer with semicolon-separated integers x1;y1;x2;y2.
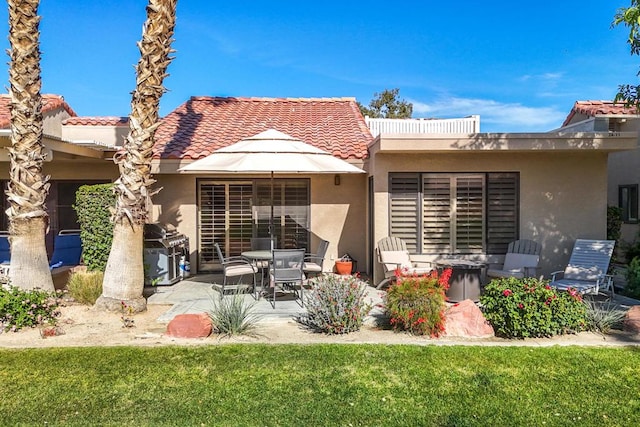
385;269;451;337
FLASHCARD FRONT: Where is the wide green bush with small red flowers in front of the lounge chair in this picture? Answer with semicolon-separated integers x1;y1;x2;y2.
480;277;587;338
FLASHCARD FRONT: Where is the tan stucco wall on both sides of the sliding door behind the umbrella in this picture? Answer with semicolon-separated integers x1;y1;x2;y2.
152;174;367;271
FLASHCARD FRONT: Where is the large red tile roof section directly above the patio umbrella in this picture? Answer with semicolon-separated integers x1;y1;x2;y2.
154;96;373;160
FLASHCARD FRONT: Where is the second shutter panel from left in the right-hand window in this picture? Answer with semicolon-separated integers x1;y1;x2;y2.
422;174;453;253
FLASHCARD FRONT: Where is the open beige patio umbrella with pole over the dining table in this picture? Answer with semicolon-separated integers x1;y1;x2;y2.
178;129;364;242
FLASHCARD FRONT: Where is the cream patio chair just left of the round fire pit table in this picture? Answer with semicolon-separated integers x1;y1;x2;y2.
376;236;433;289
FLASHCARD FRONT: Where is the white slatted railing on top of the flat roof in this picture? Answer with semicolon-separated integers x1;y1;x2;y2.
364;116;480;137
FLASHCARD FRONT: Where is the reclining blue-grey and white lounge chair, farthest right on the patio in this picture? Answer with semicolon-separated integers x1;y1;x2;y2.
550;239;616;296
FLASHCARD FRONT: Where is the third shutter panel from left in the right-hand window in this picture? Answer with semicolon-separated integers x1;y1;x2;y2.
453;175;484;254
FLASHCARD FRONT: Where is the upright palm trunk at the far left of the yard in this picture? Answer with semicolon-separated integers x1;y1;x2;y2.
7;0;54;291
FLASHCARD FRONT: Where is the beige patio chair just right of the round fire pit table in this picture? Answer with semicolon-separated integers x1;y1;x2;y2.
487;240;541;279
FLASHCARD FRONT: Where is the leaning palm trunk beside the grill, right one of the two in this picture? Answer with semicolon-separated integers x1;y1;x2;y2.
96;0;177;312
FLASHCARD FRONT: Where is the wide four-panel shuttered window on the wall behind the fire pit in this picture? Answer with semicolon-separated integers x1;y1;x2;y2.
389;173;519;254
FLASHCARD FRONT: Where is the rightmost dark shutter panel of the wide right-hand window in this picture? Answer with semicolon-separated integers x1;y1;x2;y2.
487;173;520;254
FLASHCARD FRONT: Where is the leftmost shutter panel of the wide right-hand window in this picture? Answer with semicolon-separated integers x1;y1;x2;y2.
389;173;420;253
